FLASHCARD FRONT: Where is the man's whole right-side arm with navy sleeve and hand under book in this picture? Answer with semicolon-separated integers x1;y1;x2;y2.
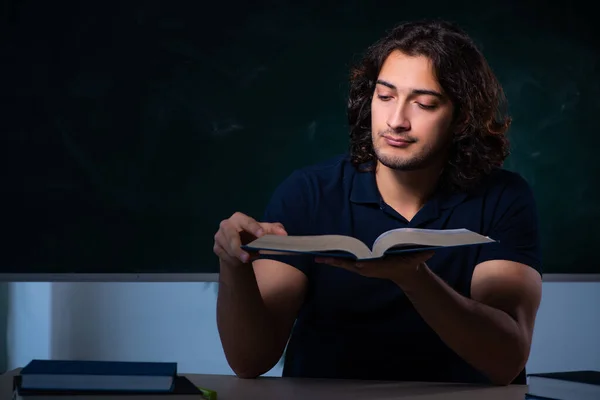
317;175;542;384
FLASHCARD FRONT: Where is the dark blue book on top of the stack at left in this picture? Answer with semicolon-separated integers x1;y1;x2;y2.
20;360;177;392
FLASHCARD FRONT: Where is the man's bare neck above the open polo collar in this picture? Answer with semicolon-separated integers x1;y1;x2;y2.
375;162;442;221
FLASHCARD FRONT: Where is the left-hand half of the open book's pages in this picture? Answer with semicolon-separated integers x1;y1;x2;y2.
247;235;371;258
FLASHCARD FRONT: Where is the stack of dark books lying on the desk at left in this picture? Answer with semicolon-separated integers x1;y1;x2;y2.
13;360;216;400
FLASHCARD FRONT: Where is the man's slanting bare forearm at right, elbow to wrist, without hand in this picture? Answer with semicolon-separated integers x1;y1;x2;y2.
397;265;528;384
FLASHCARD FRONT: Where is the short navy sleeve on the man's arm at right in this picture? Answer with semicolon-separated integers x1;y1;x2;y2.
477;174;542;274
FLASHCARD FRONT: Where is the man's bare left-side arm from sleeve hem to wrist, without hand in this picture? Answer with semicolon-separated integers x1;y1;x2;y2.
217;260;307;378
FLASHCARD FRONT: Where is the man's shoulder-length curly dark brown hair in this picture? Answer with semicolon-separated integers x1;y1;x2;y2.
348;20;511;190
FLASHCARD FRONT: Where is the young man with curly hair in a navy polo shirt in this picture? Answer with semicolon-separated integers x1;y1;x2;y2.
214;22;541;384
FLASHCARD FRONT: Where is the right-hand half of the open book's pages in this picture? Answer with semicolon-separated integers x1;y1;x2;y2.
373;228;494;256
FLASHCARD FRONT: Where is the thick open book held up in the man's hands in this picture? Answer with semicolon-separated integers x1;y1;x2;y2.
242;228;495;260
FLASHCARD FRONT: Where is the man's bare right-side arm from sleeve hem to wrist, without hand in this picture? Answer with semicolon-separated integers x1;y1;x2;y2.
398;260;542;385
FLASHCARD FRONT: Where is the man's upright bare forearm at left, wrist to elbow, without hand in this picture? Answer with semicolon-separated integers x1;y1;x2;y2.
217;266;279;378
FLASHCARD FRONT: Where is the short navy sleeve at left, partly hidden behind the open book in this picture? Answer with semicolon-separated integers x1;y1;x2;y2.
260;171;313;276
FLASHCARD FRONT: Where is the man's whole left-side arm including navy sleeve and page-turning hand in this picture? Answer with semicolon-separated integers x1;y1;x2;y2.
215;172;312;378
